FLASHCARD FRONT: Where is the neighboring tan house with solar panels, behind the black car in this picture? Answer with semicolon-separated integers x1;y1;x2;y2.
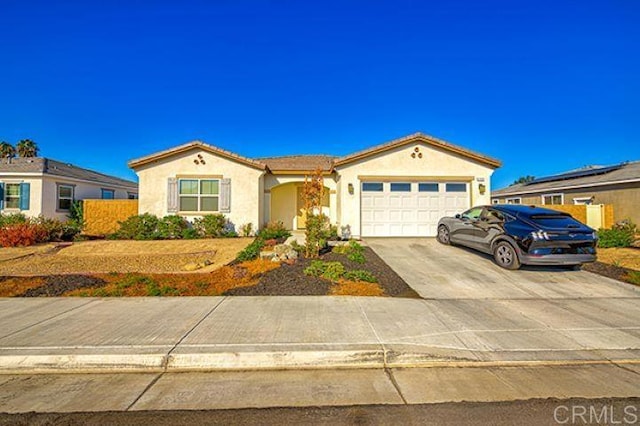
491;161;640;223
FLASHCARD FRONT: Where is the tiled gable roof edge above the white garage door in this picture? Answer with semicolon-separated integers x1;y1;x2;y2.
334;132;502;168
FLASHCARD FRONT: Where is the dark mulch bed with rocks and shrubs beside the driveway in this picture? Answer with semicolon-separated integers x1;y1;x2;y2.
224;247;420;298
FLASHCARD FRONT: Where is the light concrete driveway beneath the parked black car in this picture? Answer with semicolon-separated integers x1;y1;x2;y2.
366;238;640;300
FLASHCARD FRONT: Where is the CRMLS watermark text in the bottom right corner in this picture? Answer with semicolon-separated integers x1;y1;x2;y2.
553;404;640;425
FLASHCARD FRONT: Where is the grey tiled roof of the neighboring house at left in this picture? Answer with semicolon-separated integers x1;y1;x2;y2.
0;157;138;189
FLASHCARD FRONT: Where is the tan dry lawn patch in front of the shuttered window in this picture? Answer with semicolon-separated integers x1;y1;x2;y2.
0;238;252;276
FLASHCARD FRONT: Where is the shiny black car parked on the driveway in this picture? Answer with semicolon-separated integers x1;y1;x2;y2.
438;204;597;269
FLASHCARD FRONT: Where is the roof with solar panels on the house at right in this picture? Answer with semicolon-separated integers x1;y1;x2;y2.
491;161;640;197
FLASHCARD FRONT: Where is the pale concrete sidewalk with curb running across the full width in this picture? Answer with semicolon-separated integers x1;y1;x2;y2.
0;294;640;373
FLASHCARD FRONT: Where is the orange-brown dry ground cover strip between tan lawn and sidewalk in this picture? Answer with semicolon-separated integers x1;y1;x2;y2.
63;260;280;297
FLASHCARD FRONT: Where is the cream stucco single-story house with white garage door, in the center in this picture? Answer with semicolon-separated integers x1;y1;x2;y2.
129;133;500;237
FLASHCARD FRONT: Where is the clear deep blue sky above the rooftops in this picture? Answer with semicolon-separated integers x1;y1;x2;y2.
0;0;640;188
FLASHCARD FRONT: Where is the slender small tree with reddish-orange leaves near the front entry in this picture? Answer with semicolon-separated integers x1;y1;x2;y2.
303;169;329;258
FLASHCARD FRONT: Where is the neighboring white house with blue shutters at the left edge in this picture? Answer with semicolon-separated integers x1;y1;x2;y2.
0;157;138;220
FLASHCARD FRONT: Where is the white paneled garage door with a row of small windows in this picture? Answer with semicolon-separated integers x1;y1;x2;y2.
360;182;470;237
